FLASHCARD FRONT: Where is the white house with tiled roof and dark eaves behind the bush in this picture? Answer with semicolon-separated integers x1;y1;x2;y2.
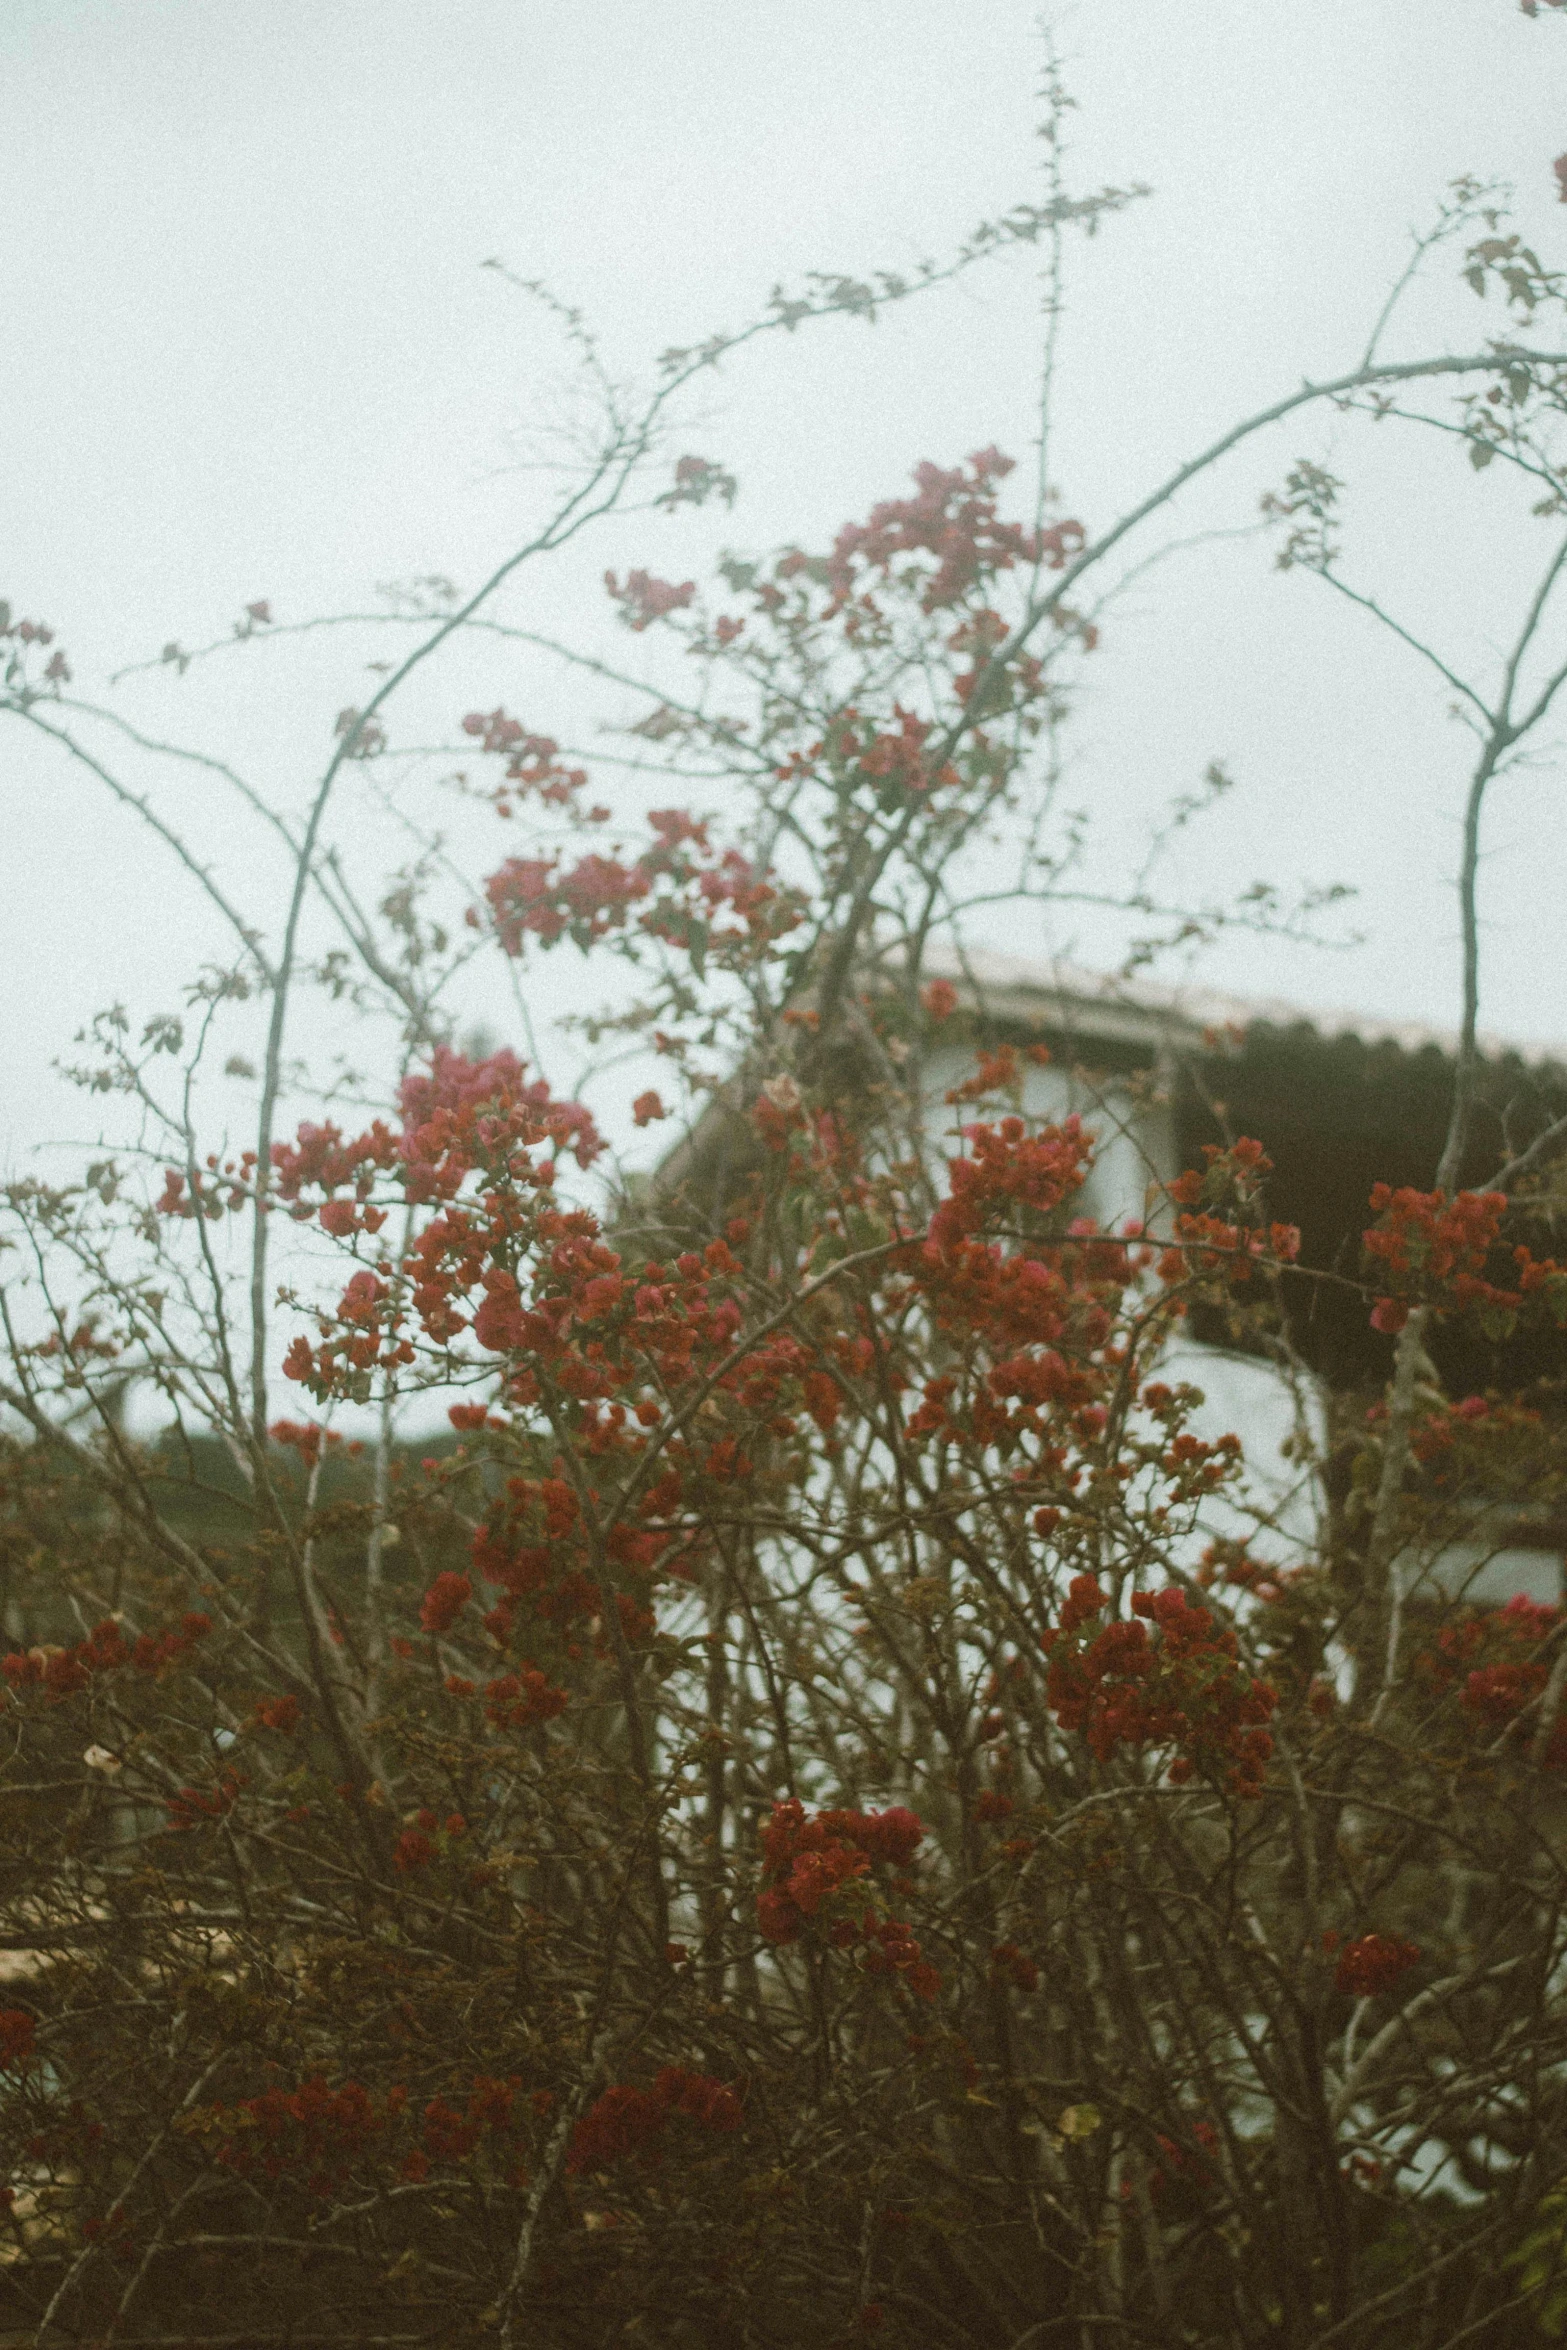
660;954;1567;1605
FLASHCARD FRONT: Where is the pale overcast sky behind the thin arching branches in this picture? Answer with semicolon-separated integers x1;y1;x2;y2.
0;0;1567;1168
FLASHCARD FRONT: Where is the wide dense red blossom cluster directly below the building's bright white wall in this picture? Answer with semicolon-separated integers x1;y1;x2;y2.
1045;1575;1278;1795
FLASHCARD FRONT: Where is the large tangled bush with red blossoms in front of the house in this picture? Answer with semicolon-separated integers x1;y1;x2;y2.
0;137;1567;2350
